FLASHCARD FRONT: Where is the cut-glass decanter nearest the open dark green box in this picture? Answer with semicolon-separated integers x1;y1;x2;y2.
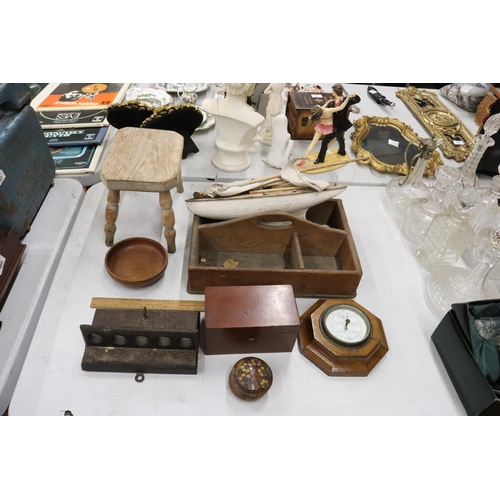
427;227;500;315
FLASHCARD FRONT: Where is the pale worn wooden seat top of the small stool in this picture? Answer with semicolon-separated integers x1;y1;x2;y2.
101;127;184;192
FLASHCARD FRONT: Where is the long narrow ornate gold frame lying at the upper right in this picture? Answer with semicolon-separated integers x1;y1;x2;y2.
396;86;474;162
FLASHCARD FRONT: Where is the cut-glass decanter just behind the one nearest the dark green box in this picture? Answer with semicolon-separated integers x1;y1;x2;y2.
417;188;479;271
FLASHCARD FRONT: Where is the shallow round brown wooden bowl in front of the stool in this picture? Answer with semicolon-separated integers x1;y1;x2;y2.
104;238;168;287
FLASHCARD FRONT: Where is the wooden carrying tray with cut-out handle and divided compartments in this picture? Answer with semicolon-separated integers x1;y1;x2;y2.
187;199;362;298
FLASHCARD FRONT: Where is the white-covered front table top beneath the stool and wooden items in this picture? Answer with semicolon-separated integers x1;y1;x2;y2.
9;180;465;416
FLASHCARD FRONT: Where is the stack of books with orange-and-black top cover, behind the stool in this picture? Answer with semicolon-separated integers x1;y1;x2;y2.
31;83;130;175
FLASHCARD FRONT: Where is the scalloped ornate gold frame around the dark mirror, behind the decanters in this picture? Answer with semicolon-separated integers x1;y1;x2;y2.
351;116;443;176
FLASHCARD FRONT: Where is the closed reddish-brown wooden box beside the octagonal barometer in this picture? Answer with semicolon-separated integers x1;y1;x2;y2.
200;285;300;354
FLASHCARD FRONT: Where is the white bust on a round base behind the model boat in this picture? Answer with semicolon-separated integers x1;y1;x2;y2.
202;83;264;172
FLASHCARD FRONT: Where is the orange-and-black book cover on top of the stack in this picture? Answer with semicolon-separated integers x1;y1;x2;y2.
31;83;130;111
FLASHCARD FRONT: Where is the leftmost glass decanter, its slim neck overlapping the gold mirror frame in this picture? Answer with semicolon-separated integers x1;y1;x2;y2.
385;139;441;213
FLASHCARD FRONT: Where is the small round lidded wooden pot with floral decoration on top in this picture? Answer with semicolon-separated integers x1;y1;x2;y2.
229;357;273;401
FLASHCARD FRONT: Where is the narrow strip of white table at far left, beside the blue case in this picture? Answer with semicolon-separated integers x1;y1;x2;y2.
0;179;84;415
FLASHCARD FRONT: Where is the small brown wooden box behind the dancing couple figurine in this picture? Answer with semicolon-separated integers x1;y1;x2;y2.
286;92;332;139
